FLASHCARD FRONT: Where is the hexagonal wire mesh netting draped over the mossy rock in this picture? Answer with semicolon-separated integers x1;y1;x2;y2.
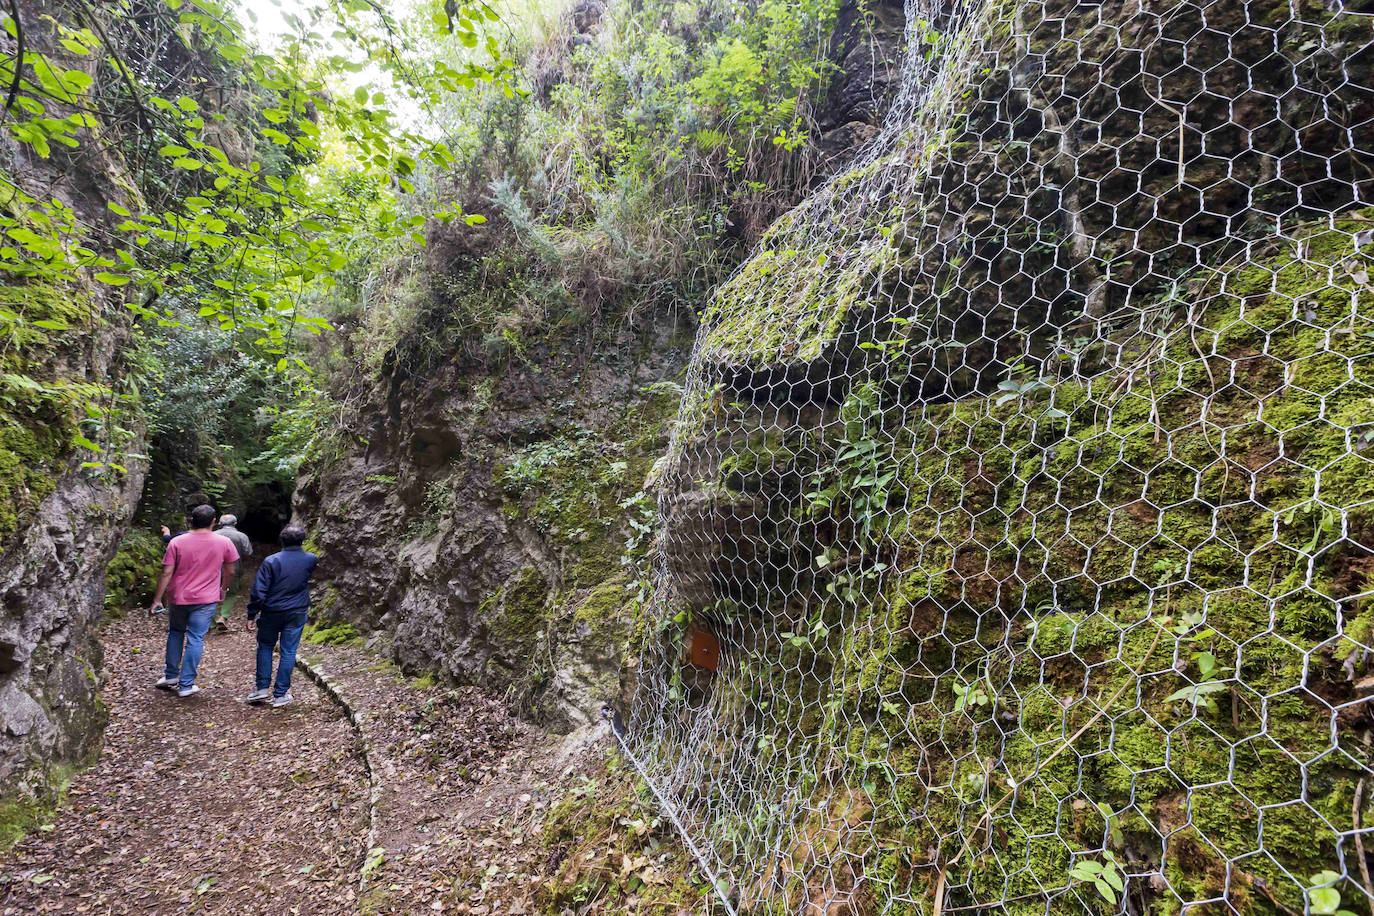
629;0;1374;916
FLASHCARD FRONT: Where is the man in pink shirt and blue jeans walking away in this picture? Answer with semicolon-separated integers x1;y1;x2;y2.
148;505;239;696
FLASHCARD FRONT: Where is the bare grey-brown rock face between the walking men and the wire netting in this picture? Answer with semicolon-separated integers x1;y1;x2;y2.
297;1;901;728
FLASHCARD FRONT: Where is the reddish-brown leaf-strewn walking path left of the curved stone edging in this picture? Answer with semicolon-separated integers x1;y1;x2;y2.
0;615;368;916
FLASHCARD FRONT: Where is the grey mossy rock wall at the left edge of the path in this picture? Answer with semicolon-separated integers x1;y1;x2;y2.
0;7;144;805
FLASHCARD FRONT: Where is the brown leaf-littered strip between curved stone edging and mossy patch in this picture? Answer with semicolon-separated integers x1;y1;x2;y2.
292;645;605;916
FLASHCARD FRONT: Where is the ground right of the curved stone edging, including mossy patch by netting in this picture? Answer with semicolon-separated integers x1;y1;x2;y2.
288;645;713;916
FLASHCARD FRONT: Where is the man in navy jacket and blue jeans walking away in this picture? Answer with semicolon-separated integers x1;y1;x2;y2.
247;525;319;709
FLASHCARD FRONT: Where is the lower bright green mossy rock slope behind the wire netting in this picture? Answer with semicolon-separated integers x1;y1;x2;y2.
651;210;1374;913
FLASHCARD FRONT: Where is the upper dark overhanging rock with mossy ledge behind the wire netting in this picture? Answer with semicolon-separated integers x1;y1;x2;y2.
688;0;1374;406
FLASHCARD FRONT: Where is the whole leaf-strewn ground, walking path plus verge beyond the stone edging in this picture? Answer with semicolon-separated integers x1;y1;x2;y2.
0;615;710;916
